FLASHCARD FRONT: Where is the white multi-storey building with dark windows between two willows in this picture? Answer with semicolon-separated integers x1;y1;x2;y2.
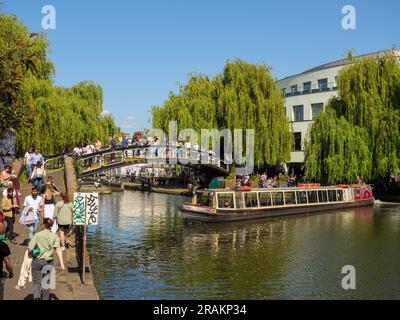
278;51;400;172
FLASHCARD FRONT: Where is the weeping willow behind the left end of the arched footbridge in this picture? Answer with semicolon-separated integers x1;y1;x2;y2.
17;79;119;154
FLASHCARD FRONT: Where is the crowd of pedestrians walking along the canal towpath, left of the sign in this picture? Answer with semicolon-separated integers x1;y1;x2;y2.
0;153;73;300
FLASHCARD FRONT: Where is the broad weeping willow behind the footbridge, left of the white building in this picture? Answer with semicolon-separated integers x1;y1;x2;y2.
152;60;292;167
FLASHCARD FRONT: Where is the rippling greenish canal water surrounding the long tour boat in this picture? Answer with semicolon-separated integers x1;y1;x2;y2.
88;192;400;300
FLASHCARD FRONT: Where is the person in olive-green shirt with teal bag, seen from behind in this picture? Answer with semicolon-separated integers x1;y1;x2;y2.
28;218;65;300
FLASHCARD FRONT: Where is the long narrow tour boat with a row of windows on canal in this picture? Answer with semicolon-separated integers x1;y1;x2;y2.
180;185;375;222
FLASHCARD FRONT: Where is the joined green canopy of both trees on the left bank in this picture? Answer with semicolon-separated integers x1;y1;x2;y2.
0;14;119;154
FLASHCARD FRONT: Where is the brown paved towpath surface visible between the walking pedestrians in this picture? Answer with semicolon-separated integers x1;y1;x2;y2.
4;170;99;300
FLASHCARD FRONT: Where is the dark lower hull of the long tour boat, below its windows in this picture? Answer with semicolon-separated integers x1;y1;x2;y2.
181;198;375;223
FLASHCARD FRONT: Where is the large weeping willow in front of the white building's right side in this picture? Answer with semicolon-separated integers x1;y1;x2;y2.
305;52;400;184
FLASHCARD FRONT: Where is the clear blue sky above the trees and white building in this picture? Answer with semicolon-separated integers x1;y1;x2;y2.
2;0;400;132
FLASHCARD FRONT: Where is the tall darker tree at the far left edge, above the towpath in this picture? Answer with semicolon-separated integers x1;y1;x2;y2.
0;14;54;135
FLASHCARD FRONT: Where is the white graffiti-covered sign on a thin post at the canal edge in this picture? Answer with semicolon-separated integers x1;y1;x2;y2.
72;192;99;283
